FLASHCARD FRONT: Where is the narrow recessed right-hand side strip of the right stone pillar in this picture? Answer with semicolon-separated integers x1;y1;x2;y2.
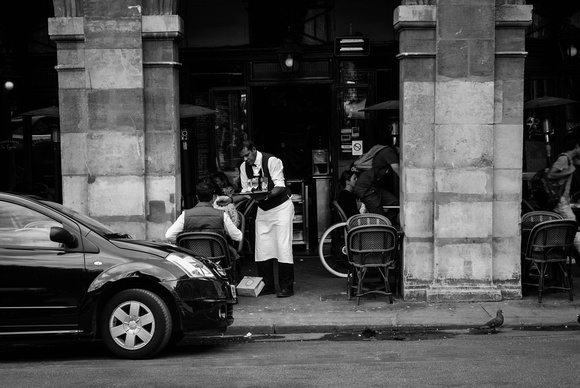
492;0;532;299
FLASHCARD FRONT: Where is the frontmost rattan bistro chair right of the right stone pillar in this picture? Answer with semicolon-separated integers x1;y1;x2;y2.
522;220;578;303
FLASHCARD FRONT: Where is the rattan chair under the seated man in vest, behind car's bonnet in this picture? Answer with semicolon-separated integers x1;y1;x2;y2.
176;232;237;284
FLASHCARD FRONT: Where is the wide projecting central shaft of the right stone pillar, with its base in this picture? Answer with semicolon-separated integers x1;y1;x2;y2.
427;0;501;301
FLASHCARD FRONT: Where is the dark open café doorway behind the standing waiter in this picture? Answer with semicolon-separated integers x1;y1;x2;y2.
251;84;332;253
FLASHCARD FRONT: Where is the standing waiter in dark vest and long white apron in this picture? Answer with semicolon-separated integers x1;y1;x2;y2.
240;140;294;298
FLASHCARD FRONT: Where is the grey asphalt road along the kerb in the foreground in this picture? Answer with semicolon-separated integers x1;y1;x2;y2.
0;329;580;388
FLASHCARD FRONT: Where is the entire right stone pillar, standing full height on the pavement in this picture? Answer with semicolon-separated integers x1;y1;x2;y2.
394;0;531;301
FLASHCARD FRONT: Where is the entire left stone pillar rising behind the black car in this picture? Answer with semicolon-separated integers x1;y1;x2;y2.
49;0;182;239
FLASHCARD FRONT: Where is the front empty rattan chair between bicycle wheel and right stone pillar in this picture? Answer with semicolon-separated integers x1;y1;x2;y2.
347;224;399;305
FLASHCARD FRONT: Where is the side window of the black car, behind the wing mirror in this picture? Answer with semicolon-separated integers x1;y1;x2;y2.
0;201;62;248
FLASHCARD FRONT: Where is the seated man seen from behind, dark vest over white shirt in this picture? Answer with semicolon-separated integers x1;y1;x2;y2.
165;180;244;259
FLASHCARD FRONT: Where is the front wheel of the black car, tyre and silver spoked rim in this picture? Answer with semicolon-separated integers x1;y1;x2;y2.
100;288;172;359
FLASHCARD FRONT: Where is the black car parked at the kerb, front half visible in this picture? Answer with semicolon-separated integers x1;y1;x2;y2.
0;193;236;359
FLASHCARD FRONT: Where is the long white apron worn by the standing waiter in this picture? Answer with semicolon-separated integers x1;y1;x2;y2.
255;200;294;264
